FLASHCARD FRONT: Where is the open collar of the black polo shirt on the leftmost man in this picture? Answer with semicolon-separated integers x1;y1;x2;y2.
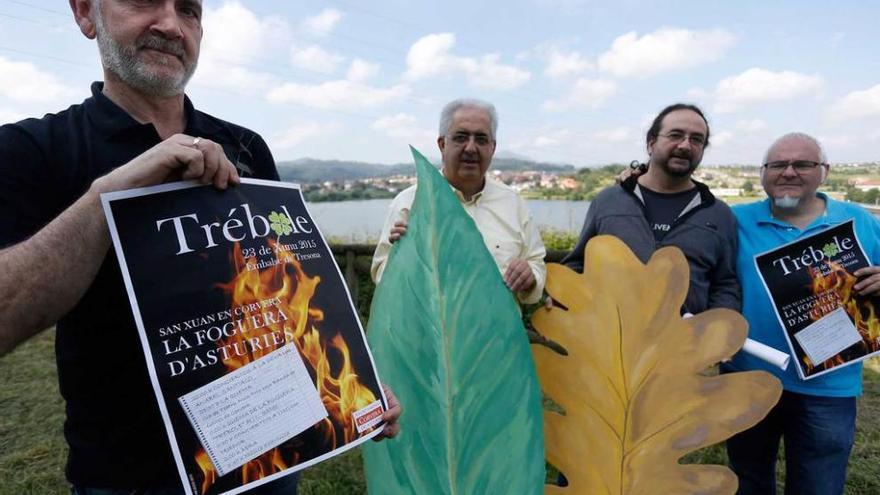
84;81;221;138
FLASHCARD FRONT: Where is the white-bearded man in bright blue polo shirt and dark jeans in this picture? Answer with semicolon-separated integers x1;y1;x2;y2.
724;133;880;495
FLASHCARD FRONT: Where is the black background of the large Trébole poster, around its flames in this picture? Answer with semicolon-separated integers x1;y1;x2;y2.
102;180;387;494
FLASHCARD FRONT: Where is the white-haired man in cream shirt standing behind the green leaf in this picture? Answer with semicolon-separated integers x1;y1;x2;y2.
370;99;547;304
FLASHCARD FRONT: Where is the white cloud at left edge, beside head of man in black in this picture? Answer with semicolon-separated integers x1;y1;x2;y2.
0;57;74;103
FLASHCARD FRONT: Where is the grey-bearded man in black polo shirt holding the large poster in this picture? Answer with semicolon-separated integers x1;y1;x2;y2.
0;0;400;495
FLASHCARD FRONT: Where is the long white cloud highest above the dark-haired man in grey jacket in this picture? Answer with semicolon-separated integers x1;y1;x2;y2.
599;28;736;77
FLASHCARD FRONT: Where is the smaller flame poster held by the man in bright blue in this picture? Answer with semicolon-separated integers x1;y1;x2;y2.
755;220;880;380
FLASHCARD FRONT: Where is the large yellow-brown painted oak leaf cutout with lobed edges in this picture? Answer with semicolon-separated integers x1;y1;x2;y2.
532;236;782;495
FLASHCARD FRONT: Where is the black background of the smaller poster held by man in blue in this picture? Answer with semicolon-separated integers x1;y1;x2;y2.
755;220;880;379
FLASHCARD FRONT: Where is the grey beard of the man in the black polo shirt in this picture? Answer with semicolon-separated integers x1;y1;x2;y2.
95;12;197;97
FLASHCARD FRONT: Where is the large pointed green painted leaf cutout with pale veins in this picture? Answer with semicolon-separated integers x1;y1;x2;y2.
364;150;545;495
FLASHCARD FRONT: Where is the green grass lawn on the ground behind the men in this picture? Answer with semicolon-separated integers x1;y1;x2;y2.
0;331;880;495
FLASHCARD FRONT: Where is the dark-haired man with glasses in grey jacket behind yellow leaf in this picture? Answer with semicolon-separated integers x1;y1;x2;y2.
562;103;741;314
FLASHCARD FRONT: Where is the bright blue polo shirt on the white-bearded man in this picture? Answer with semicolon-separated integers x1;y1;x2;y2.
725;193;880;397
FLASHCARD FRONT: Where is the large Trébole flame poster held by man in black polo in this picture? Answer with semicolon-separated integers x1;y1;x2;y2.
101;179;387;495
